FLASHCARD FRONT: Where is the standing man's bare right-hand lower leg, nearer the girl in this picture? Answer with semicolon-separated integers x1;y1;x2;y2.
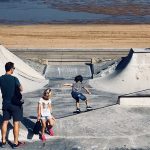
13;121;20;145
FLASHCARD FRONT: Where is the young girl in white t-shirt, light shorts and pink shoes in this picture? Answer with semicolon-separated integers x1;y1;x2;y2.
37;89;55;141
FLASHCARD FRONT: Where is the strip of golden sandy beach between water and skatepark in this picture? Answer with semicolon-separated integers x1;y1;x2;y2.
0;24;150;48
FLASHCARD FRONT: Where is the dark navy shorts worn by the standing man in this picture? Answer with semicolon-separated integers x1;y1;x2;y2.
3;104;23;121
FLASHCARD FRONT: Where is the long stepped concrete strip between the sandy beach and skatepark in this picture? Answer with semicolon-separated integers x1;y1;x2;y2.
10;49;128;59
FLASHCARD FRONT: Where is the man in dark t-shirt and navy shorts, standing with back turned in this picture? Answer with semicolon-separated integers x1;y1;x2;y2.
0;62;24;148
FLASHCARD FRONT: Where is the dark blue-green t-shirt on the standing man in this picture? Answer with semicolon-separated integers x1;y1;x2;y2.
0;74;20;106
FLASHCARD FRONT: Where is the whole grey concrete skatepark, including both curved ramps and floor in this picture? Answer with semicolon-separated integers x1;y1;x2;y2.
0;45;150;150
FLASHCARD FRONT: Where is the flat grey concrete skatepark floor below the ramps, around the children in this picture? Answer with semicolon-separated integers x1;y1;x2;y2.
0;80;150;150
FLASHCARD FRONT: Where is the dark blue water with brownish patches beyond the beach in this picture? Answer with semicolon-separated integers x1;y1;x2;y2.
0;0;150;24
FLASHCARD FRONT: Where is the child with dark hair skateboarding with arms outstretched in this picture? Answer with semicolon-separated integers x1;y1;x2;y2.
64;75;92;113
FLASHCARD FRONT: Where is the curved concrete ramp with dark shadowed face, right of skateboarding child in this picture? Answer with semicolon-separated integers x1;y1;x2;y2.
90;49;150;94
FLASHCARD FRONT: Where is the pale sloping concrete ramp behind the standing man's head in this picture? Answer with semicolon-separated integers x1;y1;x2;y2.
0;45;48;92
